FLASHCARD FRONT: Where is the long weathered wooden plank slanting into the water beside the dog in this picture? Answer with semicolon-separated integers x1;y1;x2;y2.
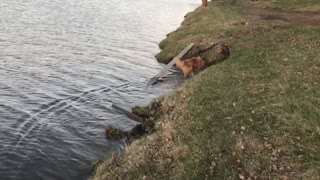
148;43;194;85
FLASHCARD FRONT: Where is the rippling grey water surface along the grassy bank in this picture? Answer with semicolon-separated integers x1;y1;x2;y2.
0;0;199;180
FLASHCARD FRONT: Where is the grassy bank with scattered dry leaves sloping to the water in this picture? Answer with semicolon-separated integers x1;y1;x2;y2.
93;0;320;179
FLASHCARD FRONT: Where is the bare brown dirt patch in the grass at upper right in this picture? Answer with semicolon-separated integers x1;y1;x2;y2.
247;9;320;26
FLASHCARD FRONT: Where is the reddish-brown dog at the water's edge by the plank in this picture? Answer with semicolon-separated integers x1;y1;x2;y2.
176;57;205;78
